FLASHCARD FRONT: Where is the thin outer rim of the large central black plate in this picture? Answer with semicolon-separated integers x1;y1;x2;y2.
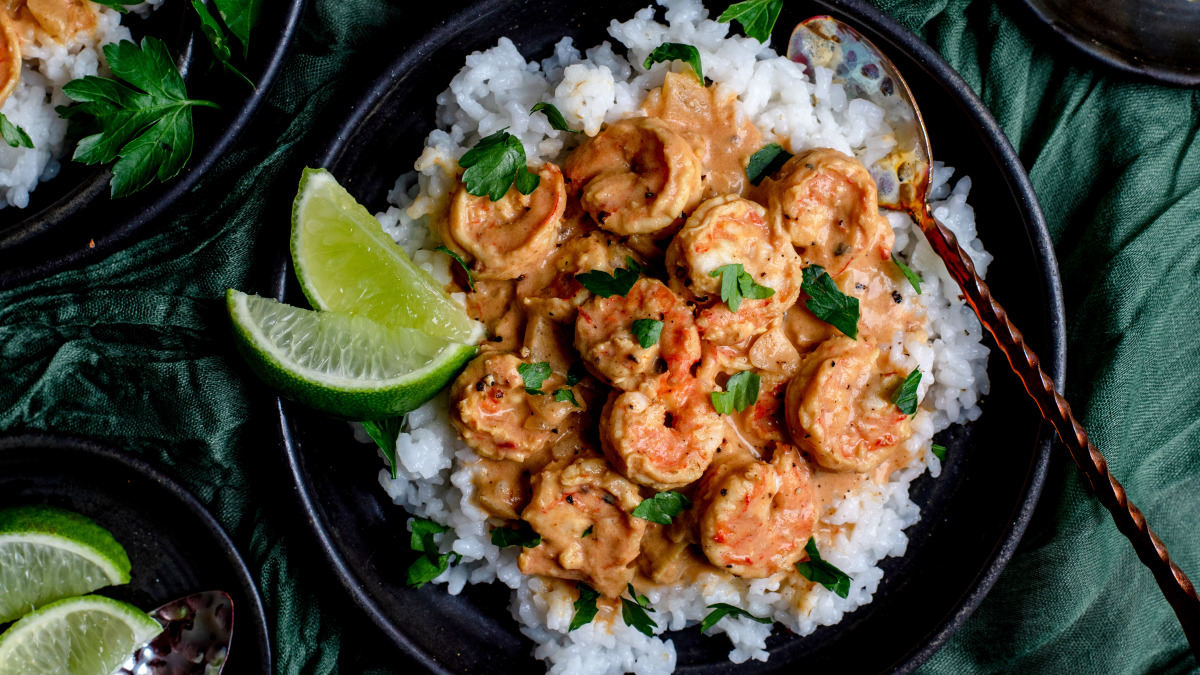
270;0;1067;675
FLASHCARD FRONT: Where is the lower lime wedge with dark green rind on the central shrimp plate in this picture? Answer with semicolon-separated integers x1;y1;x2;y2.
226;288;475;419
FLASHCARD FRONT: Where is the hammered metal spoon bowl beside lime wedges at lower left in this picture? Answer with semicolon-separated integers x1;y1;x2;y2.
113;591;233;675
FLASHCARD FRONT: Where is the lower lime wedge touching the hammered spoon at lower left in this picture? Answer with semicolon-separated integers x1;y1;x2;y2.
0;596;162;675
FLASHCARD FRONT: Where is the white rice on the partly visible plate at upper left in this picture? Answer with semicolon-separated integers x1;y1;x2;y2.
0;0;163;209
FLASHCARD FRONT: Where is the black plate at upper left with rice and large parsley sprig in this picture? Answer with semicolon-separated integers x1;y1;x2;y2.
0;0;305;288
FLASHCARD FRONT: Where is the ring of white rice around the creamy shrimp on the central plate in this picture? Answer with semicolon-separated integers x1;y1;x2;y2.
359;0;991;675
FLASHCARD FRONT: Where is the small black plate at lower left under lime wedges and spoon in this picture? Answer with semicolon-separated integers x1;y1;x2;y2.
0;434;271;675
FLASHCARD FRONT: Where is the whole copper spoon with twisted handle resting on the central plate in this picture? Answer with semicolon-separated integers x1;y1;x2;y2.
787;16;1200;655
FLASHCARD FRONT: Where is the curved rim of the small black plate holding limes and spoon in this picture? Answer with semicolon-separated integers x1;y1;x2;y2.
0;431;275;673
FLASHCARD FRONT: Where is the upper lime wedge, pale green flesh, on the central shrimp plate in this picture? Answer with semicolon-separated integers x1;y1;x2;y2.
292;168;484;345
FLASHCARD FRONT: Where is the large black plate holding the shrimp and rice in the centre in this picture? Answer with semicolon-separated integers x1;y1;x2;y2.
275;0;1066;674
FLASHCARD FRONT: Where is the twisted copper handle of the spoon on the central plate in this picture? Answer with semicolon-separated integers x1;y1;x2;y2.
913;205;1200;656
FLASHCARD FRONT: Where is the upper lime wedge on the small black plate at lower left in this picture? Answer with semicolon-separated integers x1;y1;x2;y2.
0;506;130;623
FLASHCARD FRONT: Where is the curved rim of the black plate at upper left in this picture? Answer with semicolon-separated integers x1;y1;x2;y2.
0;0;308;288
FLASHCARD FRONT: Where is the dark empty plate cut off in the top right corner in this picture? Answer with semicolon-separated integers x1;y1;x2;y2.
1025;0;1200;86
